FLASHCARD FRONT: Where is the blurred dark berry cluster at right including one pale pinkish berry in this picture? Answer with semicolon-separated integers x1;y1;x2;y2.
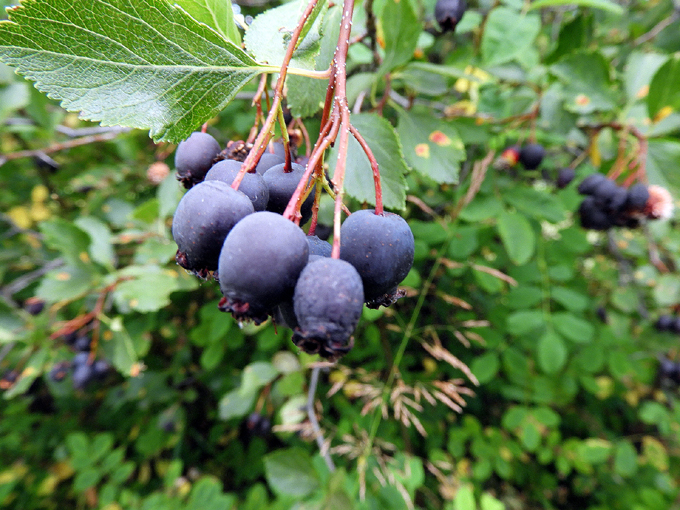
578;173;673;230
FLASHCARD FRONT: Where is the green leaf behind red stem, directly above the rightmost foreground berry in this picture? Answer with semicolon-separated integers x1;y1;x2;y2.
329;113;408;209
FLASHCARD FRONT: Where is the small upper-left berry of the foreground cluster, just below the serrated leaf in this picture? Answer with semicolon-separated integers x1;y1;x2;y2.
175;131;220;188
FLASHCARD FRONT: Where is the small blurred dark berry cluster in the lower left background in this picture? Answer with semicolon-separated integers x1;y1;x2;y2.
50;332;111;390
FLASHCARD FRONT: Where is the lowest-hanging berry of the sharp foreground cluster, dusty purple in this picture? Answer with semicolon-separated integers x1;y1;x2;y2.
293;257;364;359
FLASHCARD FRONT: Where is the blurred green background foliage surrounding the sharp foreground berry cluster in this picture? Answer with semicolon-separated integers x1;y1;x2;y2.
0;0;680;510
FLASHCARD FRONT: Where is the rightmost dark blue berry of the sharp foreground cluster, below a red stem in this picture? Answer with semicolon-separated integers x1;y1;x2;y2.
340;209;415;308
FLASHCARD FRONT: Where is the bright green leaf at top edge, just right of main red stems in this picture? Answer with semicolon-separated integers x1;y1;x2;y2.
378;0;421;75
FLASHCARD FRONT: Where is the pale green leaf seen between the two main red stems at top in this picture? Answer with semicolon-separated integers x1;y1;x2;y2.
286;7;342;117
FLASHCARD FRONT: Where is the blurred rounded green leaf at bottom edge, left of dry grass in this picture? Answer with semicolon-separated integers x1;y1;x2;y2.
264;448;319;499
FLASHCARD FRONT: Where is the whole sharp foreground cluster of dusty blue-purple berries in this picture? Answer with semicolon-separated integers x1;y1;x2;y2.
172;133;414;359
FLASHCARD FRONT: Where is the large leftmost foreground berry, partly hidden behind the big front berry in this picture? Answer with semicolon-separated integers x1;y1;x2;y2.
172;181;254;273
